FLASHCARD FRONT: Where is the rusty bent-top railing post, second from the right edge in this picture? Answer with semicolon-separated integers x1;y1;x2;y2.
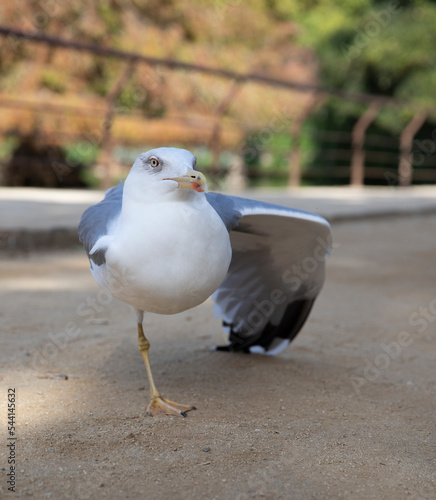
350;101;381;186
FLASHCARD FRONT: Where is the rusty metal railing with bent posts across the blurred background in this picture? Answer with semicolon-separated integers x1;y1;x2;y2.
0;26;436;186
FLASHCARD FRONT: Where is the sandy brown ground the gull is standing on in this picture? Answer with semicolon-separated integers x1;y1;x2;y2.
0;216;436;500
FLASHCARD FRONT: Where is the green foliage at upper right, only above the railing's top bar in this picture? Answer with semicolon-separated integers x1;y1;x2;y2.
294;0;436;116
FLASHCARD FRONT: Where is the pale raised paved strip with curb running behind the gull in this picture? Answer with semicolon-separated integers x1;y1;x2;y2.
0;186;436;250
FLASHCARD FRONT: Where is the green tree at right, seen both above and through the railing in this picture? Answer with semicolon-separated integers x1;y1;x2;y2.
276;0;436;182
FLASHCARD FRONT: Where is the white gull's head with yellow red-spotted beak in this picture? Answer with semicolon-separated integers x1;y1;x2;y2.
124;148;207;199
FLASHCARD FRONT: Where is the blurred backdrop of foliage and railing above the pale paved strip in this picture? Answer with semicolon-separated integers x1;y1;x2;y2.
0;0;436;190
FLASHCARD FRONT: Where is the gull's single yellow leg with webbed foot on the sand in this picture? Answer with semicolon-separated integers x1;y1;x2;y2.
138;323;195;417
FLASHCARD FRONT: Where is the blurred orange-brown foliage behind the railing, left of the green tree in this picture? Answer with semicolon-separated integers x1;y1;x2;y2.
0;0;317;188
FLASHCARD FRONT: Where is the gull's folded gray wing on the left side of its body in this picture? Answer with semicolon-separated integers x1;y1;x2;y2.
78;182;123;266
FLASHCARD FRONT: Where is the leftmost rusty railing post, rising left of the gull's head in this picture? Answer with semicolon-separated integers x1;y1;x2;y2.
100;59;135;189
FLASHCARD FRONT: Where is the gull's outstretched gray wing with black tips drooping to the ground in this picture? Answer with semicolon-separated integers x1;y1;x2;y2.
207;193;331;354
